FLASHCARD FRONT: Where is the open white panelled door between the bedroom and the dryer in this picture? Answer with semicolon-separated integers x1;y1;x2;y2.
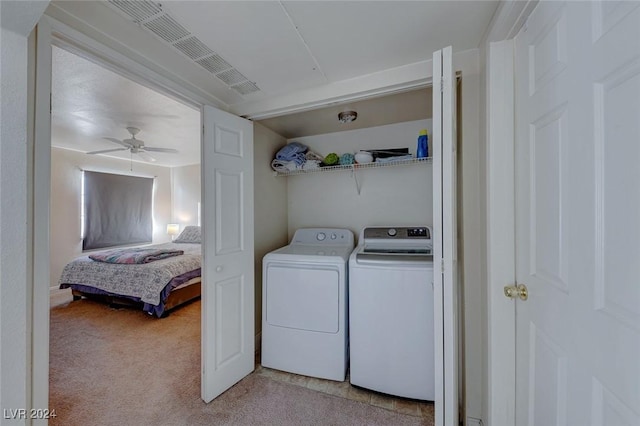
202;106;254;402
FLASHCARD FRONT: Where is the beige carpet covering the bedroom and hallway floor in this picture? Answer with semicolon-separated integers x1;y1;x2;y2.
49;300;430;426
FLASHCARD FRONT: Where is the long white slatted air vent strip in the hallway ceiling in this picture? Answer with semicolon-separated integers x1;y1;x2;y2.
106;0;260;95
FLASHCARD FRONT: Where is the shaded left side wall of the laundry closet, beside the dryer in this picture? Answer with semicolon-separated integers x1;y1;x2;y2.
253;123;288;335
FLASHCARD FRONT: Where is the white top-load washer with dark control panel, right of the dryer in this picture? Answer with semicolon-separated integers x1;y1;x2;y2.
349;226;435;401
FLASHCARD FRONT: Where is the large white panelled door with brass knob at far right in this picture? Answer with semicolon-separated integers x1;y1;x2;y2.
516;2;640;426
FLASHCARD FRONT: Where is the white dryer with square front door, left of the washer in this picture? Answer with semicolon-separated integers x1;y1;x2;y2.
261;228;354;381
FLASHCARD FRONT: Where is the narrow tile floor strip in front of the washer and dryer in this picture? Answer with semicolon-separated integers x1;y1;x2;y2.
255;360;434;420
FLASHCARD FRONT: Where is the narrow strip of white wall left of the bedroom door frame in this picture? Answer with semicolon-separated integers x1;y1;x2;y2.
0;1;47;414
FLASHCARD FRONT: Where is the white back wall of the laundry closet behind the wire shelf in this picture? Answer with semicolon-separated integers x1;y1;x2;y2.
288;119;433;238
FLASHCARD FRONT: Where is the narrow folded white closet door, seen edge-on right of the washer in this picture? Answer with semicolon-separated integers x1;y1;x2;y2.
432;46;458;425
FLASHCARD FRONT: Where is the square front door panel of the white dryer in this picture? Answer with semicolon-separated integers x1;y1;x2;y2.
264;263;340;333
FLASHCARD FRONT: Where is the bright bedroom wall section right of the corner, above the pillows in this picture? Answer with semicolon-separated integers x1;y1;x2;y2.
171;164;201;231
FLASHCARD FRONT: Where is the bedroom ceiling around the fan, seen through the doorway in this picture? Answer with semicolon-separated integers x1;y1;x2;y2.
51;47;200;167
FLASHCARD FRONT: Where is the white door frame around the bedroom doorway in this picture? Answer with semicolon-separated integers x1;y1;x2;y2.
29;15;212;412
